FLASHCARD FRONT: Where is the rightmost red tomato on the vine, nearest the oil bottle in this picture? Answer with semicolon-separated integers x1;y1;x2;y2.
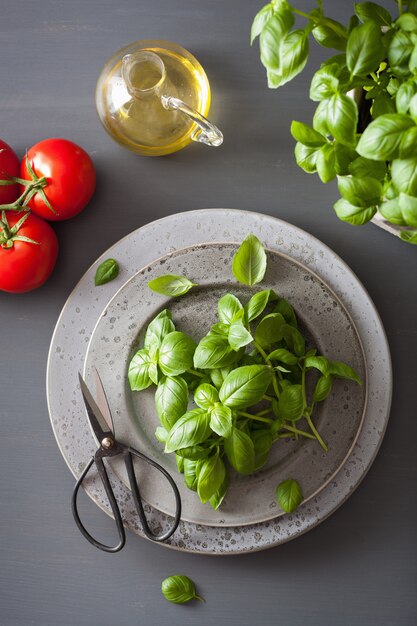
20;139;96;220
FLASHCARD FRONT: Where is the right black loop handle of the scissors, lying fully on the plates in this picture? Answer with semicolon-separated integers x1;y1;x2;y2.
123;447;181;541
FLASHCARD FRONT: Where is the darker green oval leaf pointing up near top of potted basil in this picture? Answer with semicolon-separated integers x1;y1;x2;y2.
346;21;385;77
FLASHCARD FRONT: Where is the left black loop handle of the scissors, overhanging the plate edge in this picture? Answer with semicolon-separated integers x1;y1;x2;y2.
71;451;126;552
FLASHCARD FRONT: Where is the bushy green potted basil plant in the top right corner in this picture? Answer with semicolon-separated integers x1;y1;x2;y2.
251;0;417;244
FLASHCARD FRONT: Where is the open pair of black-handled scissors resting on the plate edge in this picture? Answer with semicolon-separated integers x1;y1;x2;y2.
71;369;181;552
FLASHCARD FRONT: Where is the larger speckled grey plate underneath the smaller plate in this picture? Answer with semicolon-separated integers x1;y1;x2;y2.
47;209;392;554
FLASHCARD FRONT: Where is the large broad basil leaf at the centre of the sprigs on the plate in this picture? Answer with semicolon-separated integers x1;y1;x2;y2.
219;365;272;409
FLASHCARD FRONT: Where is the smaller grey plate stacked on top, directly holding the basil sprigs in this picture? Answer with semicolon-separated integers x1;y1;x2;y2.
84;243;367;526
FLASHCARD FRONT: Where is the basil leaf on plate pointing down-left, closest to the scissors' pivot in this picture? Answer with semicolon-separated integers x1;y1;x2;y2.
165;409;211;452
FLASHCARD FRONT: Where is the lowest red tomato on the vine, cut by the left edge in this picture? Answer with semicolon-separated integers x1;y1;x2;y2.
0;211;58;293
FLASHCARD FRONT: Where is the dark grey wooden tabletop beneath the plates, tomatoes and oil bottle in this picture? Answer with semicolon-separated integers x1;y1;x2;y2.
0;0;417;626
